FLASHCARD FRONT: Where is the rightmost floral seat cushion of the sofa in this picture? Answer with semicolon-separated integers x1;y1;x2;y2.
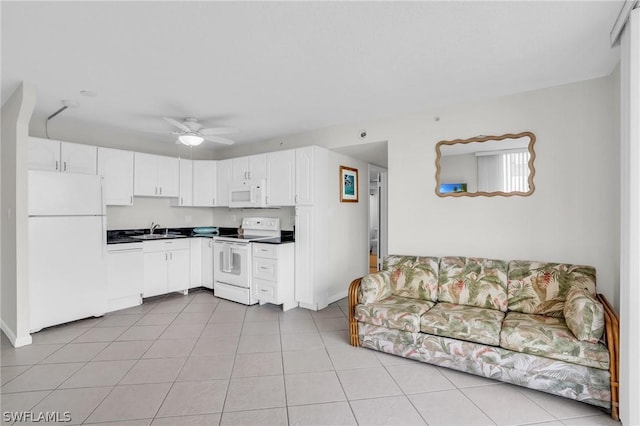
500;312;609;370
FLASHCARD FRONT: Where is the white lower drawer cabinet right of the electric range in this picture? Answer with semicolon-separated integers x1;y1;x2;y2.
251;243;298;311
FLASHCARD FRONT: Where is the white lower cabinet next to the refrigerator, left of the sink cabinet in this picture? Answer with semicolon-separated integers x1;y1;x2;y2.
107;243;144;312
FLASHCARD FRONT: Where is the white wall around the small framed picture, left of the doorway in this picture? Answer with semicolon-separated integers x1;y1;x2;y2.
327;152;369;303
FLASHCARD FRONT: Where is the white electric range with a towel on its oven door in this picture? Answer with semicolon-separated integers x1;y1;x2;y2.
213;217;280;305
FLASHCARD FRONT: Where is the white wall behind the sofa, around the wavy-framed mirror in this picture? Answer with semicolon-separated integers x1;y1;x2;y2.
222;73;620;307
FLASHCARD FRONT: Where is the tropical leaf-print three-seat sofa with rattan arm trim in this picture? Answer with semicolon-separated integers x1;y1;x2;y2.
349;255;619;420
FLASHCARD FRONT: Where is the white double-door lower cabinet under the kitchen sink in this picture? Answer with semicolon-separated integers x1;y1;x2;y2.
143;238;190;297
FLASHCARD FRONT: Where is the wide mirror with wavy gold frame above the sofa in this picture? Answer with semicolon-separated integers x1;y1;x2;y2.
436;132;536;197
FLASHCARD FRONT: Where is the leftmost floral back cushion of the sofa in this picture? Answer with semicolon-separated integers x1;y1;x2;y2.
383;255;438;302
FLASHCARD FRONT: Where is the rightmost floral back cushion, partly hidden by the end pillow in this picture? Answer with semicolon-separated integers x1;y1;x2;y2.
508;260;596;318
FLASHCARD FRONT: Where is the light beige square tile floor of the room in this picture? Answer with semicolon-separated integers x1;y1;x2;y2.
0;290;619;426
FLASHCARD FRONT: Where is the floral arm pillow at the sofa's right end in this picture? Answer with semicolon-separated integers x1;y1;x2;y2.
563;287;604;343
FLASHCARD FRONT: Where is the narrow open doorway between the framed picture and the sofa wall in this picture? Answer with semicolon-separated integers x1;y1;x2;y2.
369;164;388;273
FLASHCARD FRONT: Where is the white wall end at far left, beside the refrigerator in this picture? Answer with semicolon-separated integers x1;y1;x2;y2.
0;83;36;347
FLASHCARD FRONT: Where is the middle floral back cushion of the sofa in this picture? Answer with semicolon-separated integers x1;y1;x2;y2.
438;256;507;312
